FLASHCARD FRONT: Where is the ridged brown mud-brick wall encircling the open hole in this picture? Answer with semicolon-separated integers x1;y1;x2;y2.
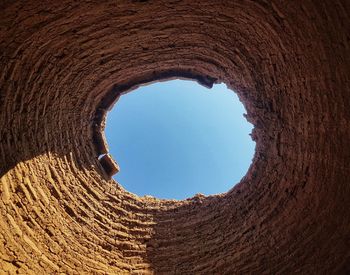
0;0;350;274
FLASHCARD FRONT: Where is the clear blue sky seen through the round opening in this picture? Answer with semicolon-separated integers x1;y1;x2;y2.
106;80;255;199
